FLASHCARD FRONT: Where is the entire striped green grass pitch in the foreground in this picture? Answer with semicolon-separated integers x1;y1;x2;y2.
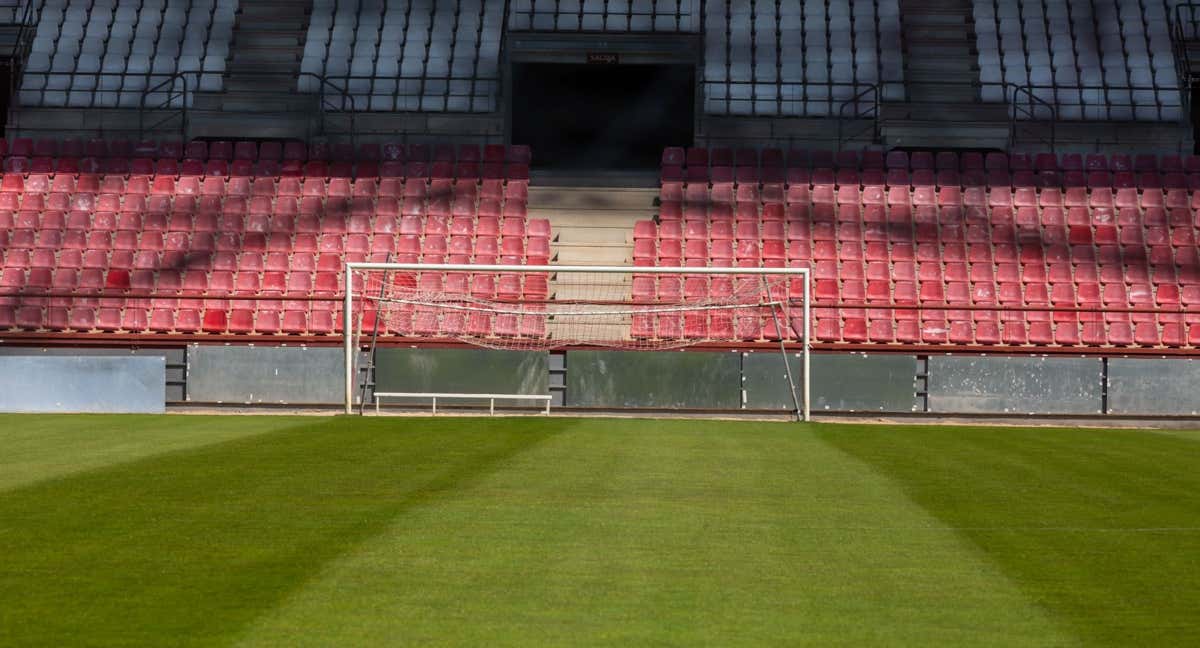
0;415;1200;647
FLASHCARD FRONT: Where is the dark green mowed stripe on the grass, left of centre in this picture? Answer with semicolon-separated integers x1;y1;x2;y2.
0;419;574;646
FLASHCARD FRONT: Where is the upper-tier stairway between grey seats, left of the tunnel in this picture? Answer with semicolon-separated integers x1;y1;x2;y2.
193;0;317;137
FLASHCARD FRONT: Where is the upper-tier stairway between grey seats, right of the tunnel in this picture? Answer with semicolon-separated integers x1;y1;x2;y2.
883;0;1008;148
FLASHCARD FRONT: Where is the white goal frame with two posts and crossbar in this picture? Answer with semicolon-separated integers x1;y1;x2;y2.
342;262;812;421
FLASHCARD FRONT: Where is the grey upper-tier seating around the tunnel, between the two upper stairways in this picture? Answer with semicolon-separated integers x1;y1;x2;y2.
299;0;904;116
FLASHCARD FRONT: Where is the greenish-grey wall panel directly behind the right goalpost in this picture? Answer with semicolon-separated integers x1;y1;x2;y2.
743;353;918;413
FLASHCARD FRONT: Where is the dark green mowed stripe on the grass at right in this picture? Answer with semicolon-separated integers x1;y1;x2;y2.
817;426;1200;646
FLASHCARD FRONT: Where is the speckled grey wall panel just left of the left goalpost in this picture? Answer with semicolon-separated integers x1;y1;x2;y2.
187;344;346;404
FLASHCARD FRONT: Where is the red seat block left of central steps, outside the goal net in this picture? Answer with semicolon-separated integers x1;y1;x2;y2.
0;140;540;335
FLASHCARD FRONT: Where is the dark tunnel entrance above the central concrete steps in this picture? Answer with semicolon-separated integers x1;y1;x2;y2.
512;64;696;169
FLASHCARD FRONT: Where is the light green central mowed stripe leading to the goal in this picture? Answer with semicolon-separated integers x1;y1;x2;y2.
241;421;1072;646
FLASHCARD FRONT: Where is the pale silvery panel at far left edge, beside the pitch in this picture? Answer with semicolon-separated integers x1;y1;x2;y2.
0;355;167;414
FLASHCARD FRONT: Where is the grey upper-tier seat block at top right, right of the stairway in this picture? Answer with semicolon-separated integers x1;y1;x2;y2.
974;0;1183;121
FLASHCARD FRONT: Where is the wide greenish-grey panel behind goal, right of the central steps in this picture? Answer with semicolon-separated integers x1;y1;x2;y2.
565;350;742;409
